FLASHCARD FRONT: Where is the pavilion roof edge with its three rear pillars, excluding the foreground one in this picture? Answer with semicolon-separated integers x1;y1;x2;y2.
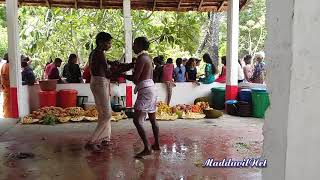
0;0;247;118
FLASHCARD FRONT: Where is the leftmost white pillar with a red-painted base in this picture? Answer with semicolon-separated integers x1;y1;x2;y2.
6;0;22;118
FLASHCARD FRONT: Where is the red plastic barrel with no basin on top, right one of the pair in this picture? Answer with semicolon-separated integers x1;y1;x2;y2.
58;89;78;108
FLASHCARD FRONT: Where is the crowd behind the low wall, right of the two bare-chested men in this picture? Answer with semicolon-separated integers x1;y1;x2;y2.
153;53;265;105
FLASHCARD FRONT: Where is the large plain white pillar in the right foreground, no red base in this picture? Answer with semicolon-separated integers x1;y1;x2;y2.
263;0;320;180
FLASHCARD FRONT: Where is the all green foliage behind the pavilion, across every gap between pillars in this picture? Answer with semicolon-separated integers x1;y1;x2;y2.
0;0;266;77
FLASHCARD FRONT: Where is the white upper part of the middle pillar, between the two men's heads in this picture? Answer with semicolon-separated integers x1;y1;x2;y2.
123;0;132;63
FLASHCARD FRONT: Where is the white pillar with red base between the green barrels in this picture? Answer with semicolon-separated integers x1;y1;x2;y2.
226;0;240;100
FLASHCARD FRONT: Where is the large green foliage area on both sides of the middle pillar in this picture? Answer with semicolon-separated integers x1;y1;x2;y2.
14;7;206;76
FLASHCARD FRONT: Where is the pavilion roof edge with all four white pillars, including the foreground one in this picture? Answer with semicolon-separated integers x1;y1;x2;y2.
1;0;320;180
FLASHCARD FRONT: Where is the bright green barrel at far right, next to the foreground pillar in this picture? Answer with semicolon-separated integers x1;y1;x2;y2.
252;91;270;118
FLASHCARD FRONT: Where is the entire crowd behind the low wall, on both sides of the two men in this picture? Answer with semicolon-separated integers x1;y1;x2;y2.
2;49;265;90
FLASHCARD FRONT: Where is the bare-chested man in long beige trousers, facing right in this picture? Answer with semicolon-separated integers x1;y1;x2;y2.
86;32;133;151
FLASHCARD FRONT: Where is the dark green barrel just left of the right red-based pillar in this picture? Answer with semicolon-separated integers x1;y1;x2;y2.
211;87;226;110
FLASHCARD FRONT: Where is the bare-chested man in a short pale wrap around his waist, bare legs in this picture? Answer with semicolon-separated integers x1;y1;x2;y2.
129;37;160;158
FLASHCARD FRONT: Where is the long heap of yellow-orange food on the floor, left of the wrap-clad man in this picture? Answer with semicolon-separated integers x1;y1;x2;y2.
21;107;127;124
